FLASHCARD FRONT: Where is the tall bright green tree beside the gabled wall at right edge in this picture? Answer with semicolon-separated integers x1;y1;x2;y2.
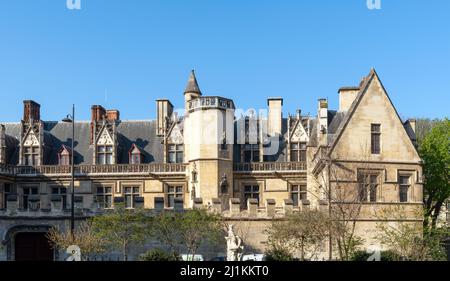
419;118;450;229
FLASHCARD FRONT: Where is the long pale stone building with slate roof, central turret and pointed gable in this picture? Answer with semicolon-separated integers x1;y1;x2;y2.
0;70;422;260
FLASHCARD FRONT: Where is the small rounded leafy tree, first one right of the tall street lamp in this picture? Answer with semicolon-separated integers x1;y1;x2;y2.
92;204;149;261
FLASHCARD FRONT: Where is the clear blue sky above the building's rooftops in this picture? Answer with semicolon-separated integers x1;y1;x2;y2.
0;0;450;121
